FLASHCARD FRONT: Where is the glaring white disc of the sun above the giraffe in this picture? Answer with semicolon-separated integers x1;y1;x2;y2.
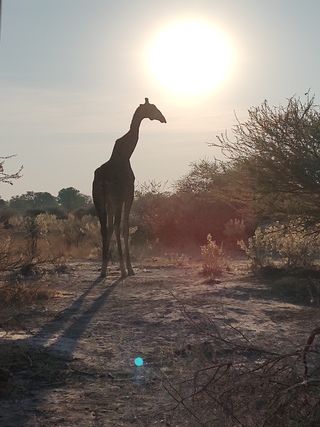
148;21;233;96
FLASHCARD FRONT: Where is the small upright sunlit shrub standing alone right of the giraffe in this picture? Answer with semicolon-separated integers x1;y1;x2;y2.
200;234;226;277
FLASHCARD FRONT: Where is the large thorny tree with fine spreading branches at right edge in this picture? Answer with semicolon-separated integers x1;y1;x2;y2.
213;97;320;224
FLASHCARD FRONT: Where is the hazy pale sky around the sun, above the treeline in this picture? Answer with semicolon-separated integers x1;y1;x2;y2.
0;0;320;199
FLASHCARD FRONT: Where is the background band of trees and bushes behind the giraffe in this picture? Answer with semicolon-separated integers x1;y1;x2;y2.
0;98;320;269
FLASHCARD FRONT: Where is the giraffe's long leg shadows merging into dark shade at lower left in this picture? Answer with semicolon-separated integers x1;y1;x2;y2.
0;278;121;427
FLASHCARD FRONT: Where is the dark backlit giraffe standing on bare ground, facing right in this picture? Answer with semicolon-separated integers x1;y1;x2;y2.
92;98;166;277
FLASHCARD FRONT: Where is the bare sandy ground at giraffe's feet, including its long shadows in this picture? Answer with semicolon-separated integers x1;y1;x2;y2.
0;262;320;427
